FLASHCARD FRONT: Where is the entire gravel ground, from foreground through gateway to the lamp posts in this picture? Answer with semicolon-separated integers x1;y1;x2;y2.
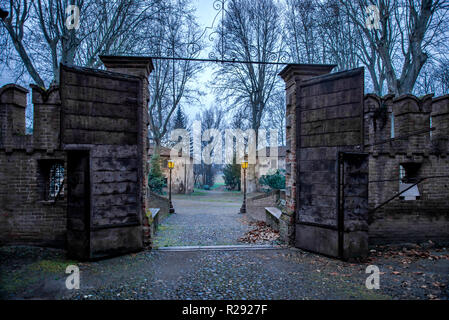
0;192;449;300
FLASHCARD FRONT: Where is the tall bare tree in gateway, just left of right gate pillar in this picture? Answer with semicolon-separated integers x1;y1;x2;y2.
215;0;284;139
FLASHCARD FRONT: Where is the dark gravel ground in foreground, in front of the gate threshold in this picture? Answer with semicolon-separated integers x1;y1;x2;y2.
0;247;449;300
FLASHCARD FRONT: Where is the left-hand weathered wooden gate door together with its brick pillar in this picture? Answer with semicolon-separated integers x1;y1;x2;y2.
60;57;151;259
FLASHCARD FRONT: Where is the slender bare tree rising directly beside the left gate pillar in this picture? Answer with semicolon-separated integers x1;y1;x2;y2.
149;0;203;152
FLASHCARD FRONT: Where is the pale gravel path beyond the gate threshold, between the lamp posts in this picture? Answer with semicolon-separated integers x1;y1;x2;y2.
154;191;266;247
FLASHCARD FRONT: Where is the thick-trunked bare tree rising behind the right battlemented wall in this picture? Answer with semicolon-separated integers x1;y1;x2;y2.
339;0;449;95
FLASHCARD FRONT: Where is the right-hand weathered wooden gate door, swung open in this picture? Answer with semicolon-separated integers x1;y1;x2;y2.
288;68;368;258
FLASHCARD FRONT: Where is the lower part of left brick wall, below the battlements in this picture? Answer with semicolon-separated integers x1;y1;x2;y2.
0;150;66;247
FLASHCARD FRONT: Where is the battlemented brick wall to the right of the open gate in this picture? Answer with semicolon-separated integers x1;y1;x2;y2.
365;95;449;244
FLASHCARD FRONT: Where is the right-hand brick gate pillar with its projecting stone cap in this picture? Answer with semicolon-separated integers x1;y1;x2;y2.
279;64;335;244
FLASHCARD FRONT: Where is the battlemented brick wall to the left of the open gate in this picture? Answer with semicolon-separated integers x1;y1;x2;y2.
0;85;66;247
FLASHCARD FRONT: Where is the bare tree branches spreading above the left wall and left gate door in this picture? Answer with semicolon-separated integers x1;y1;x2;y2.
2;0;165;87
